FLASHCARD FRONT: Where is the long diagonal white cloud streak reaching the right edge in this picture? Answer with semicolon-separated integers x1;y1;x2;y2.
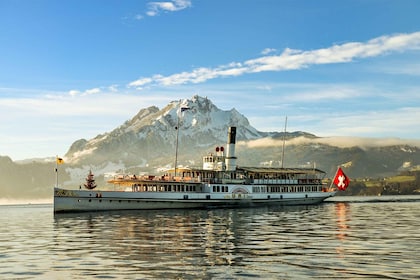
128;32;420;89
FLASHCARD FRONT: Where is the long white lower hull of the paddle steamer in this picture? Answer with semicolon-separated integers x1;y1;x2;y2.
54;188;335;213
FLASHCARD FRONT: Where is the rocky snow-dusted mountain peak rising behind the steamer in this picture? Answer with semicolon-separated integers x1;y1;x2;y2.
65;95;267;166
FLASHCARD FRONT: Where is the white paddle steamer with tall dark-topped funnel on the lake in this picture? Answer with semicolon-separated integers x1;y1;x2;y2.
54;127;336;212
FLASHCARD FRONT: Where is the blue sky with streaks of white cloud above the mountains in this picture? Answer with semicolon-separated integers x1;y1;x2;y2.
0;0;420;160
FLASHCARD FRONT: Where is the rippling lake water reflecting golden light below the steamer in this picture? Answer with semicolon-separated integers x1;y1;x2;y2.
0;196;420;279
